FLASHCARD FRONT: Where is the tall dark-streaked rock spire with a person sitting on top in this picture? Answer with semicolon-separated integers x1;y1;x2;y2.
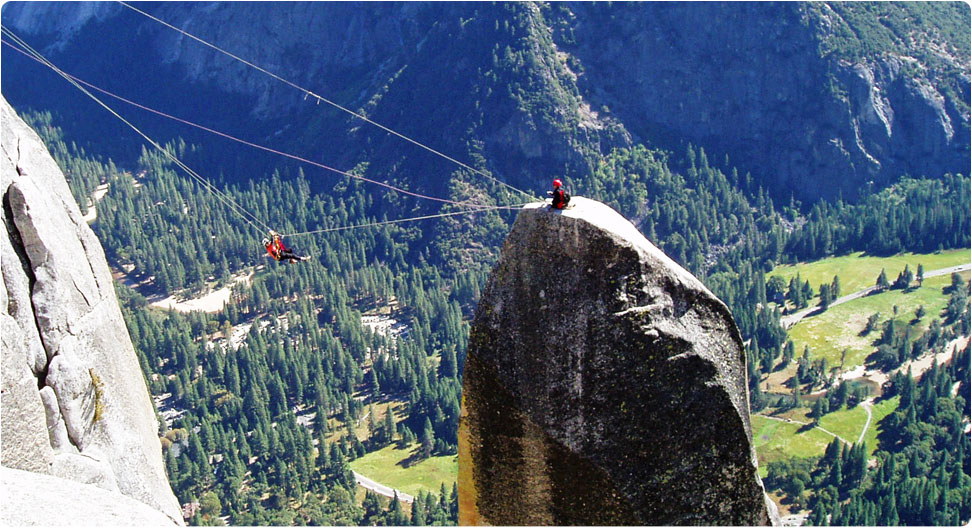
459;198;779;526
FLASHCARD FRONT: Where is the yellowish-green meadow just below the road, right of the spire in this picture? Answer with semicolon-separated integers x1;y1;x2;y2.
789;272;969;370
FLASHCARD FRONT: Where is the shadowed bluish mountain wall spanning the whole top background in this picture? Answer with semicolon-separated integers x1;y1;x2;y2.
3;2;970;199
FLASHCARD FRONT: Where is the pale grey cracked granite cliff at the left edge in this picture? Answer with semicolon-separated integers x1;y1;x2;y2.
0;100;183;525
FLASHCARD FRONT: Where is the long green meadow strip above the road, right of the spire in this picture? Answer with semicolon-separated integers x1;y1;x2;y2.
766;249;972;295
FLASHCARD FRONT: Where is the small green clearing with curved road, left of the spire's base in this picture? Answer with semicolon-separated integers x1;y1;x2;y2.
351;443;459;496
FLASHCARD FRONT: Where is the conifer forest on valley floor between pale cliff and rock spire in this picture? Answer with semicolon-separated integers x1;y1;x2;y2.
25;111;474;525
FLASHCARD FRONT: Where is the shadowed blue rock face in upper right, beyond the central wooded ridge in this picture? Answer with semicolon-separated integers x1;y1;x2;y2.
557;2;970;198
